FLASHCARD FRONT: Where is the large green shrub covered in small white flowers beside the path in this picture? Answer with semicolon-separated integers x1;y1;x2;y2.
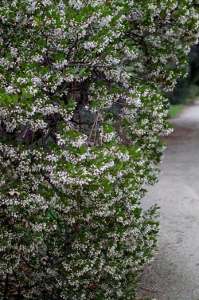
0;0;199;300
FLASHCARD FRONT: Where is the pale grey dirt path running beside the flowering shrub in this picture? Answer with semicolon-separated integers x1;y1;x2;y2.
138;101;199;300
